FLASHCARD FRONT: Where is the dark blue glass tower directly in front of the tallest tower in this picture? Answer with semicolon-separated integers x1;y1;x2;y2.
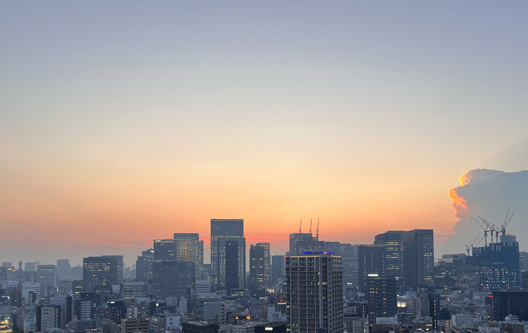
217;237;246;295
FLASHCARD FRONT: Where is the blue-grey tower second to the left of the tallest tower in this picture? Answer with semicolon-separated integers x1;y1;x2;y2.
152;239;178;298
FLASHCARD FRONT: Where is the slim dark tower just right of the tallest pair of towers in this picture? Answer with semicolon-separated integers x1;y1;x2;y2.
249;243;271;297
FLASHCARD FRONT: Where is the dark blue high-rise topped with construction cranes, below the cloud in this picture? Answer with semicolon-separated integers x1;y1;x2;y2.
469;235;521;290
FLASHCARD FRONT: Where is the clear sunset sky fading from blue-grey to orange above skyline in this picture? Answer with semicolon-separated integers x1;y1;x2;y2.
0;1;528;264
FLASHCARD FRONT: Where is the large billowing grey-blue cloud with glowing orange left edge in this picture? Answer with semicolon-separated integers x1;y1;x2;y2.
442;169;528;253
